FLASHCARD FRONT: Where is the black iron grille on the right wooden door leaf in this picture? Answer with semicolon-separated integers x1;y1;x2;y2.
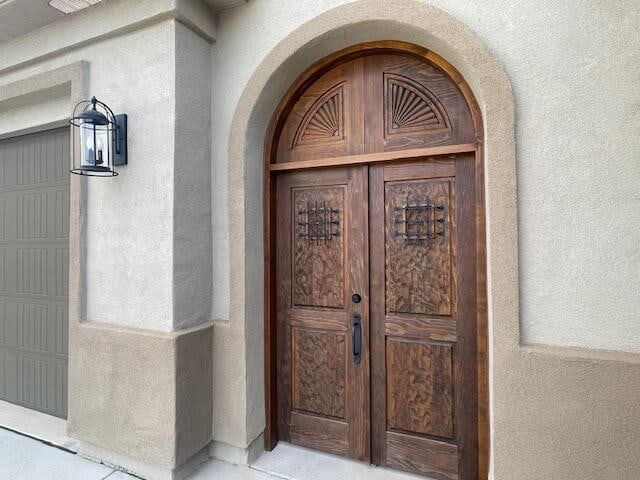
393;196;446;241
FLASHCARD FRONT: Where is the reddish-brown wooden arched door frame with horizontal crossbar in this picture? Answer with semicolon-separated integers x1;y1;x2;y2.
263;41;489;478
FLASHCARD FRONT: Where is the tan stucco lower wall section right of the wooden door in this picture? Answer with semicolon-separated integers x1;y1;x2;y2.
500;347;640;480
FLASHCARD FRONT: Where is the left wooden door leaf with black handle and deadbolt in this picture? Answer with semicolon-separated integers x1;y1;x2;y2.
276;166;370;460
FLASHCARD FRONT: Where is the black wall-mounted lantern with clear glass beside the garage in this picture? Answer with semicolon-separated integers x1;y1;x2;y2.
69;97;127;177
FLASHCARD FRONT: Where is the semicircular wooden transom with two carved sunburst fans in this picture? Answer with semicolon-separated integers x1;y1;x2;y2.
277;54;476;163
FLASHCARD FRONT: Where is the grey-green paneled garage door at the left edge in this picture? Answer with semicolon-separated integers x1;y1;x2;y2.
0;128;69;417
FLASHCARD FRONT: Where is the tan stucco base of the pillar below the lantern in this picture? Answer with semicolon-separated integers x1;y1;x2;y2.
68;323;212;468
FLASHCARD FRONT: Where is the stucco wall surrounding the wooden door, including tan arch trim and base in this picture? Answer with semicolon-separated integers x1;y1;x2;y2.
213;0;640;479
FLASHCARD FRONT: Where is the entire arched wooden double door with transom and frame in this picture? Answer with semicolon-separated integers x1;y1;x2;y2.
265;42;488;479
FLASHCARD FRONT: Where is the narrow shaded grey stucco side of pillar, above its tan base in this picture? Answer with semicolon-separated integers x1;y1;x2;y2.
173;24;212;328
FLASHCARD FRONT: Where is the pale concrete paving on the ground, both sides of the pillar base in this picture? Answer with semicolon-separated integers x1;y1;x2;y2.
0;427;428;480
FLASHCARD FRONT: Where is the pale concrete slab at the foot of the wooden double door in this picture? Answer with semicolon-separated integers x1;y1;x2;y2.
250;442;433;480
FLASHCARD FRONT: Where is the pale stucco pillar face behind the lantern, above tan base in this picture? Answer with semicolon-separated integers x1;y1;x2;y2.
80;21;175;331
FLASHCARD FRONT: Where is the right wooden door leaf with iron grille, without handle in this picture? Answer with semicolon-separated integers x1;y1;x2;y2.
370;156;478;479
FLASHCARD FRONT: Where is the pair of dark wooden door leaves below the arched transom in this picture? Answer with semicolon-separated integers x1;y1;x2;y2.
276;155;477;479
